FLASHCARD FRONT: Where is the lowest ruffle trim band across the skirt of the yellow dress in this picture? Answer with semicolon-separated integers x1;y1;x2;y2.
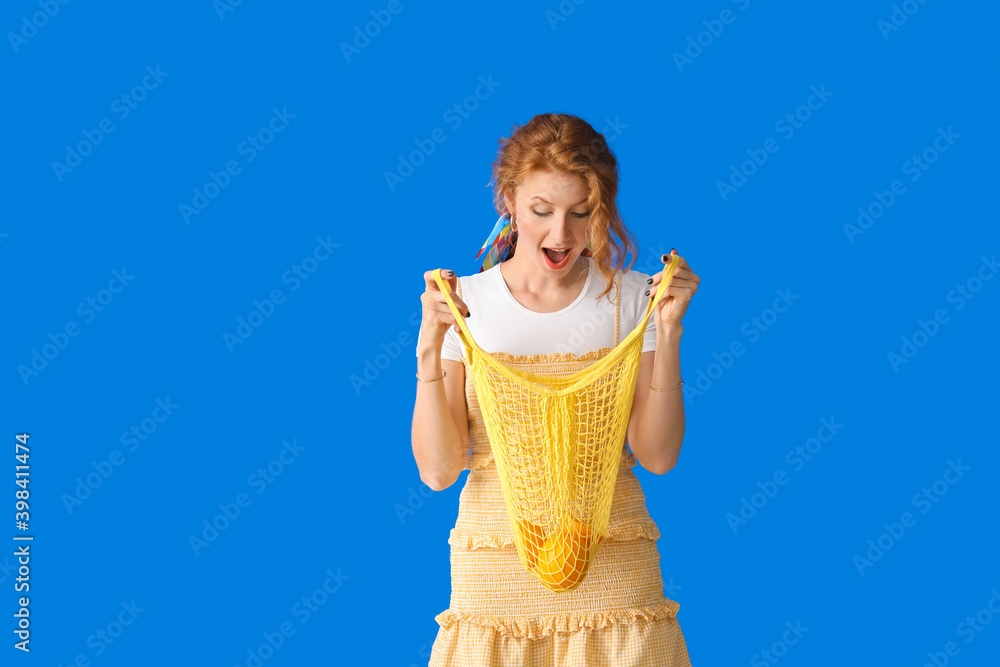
434;598;680;639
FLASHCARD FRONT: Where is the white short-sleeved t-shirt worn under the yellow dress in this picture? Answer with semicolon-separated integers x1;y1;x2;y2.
417;257;656;361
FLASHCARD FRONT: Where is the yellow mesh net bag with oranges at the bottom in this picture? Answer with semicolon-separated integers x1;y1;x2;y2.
434;255;680;592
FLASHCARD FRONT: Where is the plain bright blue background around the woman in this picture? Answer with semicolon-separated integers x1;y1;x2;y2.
0;0;1000;667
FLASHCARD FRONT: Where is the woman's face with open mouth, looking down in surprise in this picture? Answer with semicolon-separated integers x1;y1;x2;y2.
507;169;591;276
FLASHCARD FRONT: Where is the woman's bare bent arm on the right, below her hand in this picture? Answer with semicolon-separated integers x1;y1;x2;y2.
628;326;684;475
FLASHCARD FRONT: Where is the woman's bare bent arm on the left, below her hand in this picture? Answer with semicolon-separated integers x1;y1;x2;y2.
410;348;469;491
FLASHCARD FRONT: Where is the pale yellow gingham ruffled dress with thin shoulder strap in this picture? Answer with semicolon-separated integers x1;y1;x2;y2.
429;272;691;667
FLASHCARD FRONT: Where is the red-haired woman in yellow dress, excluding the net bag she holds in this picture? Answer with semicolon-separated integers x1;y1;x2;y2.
412;114;700;667
